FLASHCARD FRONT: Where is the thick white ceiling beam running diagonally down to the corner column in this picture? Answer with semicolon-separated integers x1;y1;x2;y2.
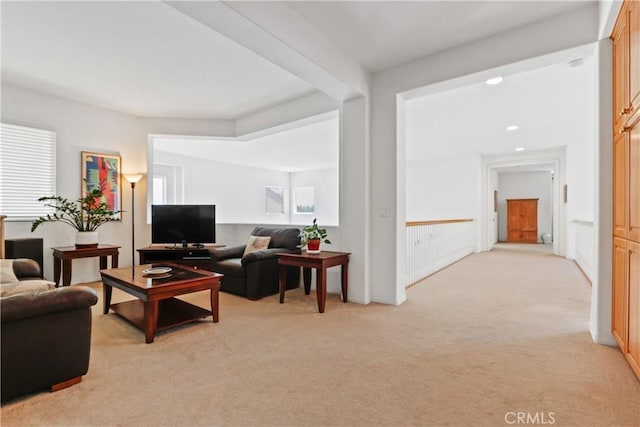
166;1;371;102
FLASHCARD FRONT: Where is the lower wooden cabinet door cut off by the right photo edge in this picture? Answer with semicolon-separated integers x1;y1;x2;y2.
626;242;640;378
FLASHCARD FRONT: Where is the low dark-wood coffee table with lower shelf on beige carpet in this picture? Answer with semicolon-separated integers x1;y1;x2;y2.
100;263;223;344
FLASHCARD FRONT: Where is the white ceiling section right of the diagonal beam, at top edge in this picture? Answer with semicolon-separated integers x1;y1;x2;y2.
287;0;596;73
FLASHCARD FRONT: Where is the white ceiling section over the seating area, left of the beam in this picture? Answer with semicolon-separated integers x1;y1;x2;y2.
1;1;315;119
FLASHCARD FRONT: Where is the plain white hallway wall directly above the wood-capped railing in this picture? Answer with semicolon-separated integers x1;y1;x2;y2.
406;156;481;221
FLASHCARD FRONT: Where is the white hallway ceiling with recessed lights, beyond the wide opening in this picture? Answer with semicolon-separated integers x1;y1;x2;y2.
405;52;595;162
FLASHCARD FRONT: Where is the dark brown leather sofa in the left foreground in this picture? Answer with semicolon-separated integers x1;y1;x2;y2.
0;259;98;401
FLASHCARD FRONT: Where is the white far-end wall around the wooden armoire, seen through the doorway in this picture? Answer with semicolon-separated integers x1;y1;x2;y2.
498;172;553;242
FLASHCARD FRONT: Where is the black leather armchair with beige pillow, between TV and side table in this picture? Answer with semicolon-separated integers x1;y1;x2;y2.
211;227;300;300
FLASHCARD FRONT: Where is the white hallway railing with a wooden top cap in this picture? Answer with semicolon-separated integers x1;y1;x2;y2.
405;219;476;286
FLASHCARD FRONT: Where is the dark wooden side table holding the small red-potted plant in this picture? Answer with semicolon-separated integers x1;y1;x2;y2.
278;251;351;313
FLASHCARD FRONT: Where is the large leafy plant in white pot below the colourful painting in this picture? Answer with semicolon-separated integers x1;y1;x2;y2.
31;188;122;248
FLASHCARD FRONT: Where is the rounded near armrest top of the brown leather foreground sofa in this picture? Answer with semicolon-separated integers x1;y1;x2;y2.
0;286;98;323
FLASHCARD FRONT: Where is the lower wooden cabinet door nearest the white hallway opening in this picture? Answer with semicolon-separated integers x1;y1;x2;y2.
611;237;629;353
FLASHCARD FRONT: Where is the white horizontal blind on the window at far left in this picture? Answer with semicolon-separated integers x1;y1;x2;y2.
0;123;56;221
